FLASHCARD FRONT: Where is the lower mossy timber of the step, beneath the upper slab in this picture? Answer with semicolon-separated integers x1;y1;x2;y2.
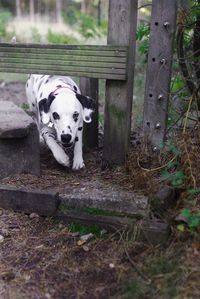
55;210;170;246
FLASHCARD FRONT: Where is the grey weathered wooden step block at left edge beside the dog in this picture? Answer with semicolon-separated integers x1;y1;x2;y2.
0;101;40;178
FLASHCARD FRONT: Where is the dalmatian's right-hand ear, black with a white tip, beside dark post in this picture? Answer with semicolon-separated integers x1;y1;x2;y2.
76;93;95;123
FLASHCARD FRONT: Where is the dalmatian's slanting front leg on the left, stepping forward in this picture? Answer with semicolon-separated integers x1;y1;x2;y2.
41;127;70;167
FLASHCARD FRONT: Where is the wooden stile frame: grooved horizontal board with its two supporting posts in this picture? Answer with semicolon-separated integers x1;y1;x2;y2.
0;0;138;165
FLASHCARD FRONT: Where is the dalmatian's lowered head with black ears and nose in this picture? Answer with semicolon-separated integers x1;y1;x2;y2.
39;91;95;147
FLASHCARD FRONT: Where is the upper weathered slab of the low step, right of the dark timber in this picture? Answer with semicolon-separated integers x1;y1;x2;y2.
60;182;148;218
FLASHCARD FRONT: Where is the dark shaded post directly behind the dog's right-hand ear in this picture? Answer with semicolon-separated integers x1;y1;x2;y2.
80;77;99;148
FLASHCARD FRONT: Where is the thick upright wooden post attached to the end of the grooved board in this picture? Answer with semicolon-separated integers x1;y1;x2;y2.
102;0;138;167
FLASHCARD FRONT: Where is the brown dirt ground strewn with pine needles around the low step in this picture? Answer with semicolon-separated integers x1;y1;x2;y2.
0;83;200;299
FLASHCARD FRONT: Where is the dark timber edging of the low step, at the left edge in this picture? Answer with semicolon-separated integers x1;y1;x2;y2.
0;186;59;216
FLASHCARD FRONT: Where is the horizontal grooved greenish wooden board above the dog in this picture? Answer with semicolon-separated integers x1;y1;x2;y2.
0;44;127;80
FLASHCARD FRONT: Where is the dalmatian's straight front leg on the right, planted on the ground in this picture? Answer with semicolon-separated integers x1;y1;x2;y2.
72;123;85;170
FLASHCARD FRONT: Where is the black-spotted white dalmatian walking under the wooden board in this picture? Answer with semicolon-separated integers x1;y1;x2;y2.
26;75;95;170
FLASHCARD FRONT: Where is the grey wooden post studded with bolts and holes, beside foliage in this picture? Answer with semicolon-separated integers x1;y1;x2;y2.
143;0;177;146
